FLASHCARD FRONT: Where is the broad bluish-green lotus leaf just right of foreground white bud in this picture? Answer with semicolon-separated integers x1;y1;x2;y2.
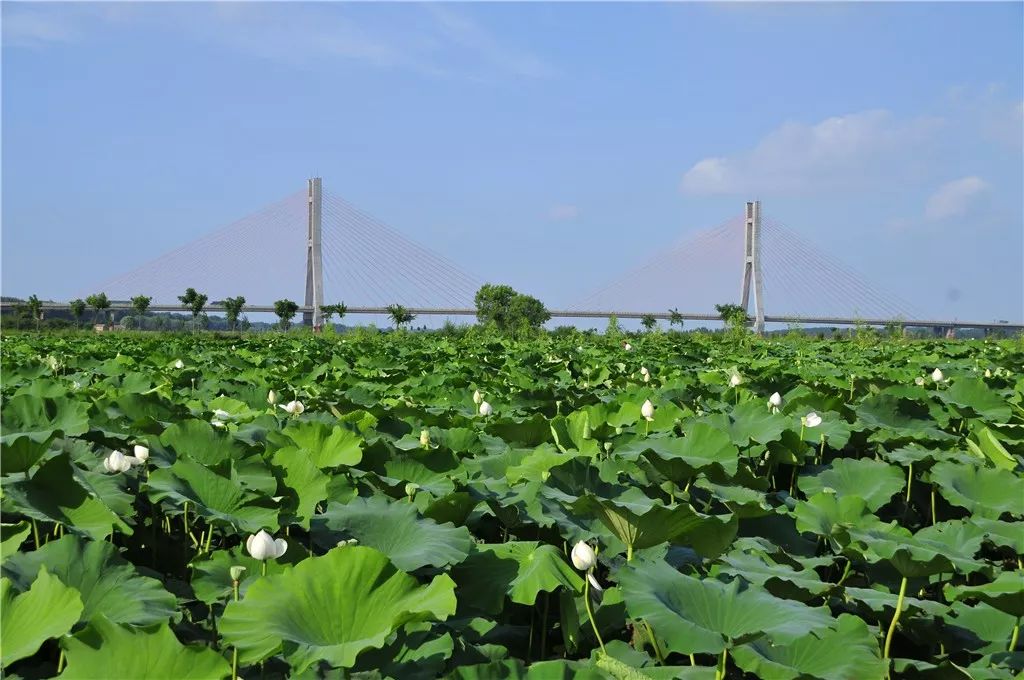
617;562;835;654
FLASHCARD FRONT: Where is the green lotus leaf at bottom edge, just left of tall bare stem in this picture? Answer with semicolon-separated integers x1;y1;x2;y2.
732;614;887;680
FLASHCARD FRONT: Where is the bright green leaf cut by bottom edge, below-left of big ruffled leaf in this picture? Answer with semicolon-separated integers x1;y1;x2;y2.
60;614;231;680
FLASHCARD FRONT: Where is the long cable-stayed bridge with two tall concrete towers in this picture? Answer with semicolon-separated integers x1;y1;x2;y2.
9;178;1024;331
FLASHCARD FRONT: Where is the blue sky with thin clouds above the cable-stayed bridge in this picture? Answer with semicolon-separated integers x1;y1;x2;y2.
2;2;1024;320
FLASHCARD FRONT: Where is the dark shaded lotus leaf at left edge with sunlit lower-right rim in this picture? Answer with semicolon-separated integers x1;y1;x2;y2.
3;454;132;541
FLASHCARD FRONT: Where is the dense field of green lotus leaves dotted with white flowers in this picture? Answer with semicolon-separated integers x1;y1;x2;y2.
0;332;1024;680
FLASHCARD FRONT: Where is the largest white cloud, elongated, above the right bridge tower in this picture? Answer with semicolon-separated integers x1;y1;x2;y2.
681;110;941;194
